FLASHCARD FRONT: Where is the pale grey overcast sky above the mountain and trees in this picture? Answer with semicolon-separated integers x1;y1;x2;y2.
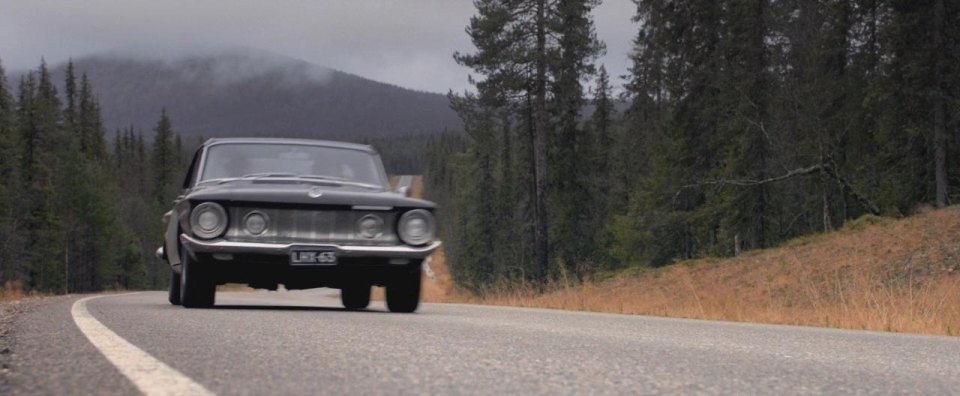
0;0;636;92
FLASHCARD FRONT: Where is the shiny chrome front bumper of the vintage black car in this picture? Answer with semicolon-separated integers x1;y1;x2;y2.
180;234;440;259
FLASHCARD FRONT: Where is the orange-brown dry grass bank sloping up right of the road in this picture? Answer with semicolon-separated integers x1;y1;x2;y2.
434;207;960;335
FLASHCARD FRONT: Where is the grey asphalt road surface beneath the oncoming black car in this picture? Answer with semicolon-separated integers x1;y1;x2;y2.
0;289;960;395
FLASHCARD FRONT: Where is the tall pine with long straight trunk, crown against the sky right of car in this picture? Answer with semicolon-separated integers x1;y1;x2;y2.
454;0;600;285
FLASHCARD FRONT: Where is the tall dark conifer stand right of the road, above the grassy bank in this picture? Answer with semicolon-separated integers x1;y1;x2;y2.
427;0;960;289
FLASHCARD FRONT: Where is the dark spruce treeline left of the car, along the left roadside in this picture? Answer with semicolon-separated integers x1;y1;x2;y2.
0;62;184;293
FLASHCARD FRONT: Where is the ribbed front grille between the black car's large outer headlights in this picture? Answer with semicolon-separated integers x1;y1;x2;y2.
224;207;400;245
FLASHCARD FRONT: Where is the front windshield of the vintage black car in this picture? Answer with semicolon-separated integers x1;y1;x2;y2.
200;143;385;187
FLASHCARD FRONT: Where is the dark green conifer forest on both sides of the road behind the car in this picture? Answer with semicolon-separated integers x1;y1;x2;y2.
0;0;960;293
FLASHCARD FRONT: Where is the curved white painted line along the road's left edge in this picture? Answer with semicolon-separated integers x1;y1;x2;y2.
70;296;214;395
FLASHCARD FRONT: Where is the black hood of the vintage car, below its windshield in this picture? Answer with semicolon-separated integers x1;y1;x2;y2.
185;181;436;209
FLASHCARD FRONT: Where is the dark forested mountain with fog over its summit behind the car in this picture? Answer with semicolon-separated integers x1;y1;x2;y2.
18;49;462;138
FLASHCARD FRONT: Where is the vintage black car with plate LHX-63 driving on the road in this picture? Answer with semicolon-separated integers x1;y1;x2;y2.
157;138;440;312
